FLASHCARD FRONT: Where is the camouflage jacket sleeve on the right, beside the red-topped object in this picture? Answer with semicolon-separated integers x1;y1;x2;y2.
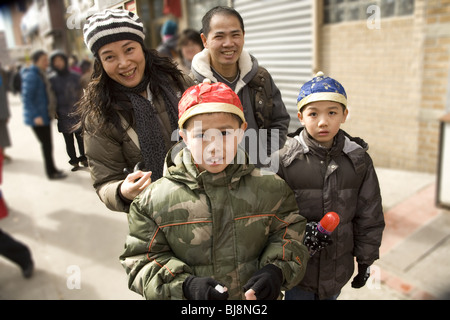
260;182;309;290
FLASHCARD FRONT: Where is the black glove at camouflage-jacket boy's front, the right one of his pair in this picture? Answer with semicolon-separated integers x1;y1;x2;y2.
244;264;283;300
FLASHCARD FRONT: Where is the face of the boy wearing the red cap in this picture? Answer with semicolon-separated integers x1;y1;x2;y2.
180;112;247;173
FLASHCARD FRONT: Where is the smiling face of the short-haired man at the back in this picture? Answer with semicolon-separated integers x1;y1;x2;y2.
201;14;244;73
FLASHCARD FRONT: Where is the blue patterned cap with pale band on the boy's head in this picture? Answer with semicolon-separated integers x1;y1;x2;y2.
297;71;347;111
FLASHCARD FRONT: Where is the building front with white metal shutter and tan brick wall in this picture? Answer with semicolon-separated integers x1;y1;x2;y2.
234;0;450;173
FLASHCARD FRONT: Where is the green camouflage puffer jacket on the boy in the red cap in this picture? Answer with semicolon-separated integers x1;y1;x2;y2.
120;144;308;299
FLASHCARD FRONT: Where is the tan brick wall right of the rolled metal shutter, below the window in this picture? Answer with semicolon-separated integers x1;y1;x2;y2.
319;0;450;172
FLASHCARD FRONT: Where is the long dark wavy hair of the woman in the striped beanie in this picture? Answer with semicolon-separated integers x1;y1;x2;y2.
74;47;184;134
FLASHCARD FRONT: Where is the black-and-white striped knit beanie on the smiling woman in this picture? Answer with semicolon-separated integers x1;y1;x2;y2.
83;9;145;55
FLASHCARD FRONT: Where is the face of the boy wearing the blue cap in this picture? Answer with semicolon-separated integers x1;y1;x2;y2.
298;101;348;148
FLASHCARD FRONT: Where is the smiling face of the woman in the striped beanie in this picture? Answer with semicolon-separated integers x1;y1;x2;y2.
98;40;145;88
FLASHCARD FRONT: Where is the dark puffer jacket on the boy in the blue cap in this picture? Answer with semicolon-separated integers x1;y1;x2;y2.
275;128;385;298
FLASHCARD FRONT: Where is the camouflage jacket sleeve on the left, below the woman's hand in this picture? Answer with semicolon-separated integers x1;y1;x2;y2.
120;192;192;300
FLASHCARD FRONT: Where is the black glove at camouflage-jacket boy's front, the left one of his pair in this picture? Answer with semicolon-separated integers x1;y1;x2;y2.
183;276;228;300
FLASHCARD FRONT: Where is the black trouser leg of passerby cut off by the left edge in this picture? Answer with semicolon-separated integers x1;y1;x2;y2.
0;229;32;269
